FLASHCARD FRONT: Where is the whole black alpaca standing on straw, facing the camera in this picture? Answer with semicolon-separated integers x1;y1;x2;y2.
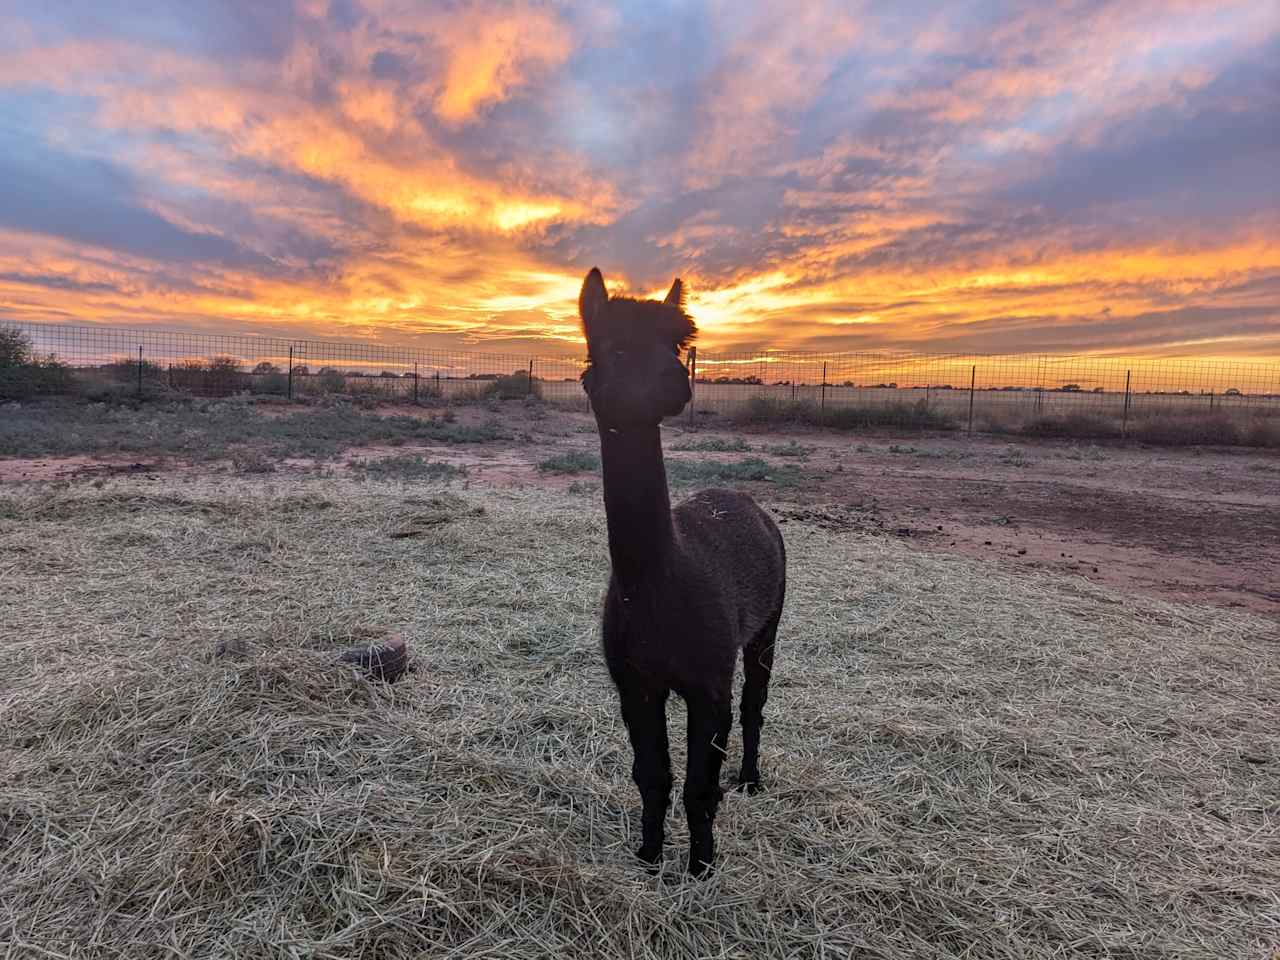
579;268;786;877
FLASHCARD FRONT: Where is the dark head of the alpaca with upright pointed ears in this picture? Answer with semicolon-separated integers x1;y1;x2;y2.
577;266;698;429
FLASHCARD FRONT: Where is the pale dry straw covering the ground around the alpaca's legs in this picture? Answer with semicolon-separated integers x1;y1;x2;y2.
0;476;1280;960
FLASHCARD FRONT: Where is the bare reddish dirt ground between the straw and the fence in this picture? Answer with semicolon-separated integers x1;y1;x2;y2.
0;403;1280;616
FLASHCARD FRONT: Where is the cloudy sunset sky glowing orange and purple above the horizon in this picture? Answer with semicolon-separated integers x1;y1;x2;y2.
0;0;1280;357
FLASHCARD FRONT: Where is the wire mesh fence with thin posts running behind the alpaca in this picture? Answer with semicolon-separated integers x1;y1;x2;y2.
0;321;1280;425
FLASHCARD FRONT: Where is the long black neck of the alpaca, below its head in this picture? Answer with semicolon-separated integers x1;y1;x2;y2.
600;425;673;584
